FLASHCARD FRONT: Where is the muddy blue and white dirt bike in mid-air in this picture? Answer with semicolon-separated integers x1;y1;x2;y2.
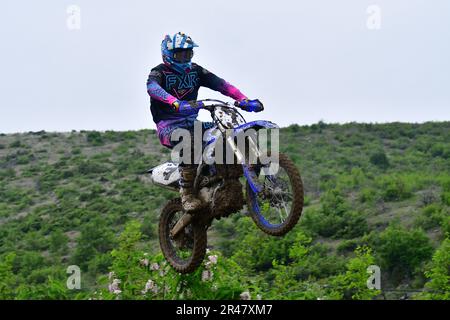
148;99;304;273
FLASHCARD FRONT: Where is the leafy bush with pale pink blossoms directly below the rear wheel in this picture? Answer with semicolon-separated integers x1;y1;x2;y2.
93;221;246;300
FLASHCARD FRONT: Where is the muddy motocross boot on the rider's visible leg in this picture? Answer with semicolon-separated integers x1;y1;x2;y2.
179;165;203;211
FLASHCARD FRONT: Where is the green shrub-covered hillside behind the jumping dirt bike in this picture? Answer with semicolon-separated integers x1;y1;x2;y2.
0;122;450;299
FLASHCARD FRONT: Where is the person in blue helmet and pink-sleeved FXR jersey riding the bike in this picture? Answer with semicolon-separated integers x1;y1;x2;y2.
147;32;263;211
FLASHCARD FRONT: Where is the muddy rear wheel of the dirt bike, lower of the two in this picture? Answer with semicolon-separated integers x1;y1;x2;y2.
159;198;207;273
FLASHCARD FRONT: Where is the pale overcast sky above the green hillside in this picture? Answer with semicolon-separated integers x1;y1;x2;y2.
0;0;450;133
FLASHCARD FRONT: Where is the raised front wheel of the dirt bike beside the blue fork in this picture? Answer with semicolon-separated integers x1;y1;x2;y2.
246;153;304;236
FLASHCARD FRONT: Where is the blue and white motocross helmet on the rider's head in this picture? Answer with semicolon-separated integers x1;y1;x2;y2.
161;32;198;73
